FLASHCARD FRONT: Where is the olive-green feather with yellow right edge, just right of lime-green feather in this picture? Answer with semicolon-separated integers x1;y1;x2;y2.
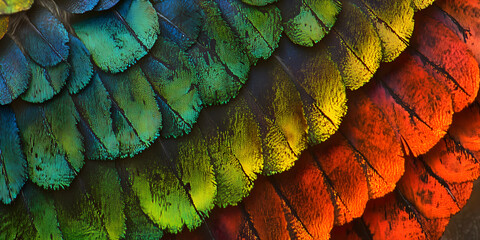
199;99;263;207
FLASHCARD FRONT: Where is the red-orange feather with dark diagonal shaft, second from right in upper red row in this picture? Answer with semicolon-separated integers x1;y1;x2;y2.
371;55;453;156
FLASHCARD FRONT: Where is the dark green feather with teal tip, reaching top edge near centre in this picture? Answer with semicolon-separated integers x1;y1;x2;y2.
188;0;250;105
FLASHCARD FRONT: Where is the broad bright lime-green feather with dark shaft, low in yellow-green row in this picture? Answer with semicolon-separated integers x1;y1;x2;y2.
125;132;216;233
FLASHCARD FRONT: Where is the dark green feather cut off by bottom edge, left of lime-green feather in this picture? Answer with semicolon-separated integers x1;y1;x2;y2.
54;162;125;239
